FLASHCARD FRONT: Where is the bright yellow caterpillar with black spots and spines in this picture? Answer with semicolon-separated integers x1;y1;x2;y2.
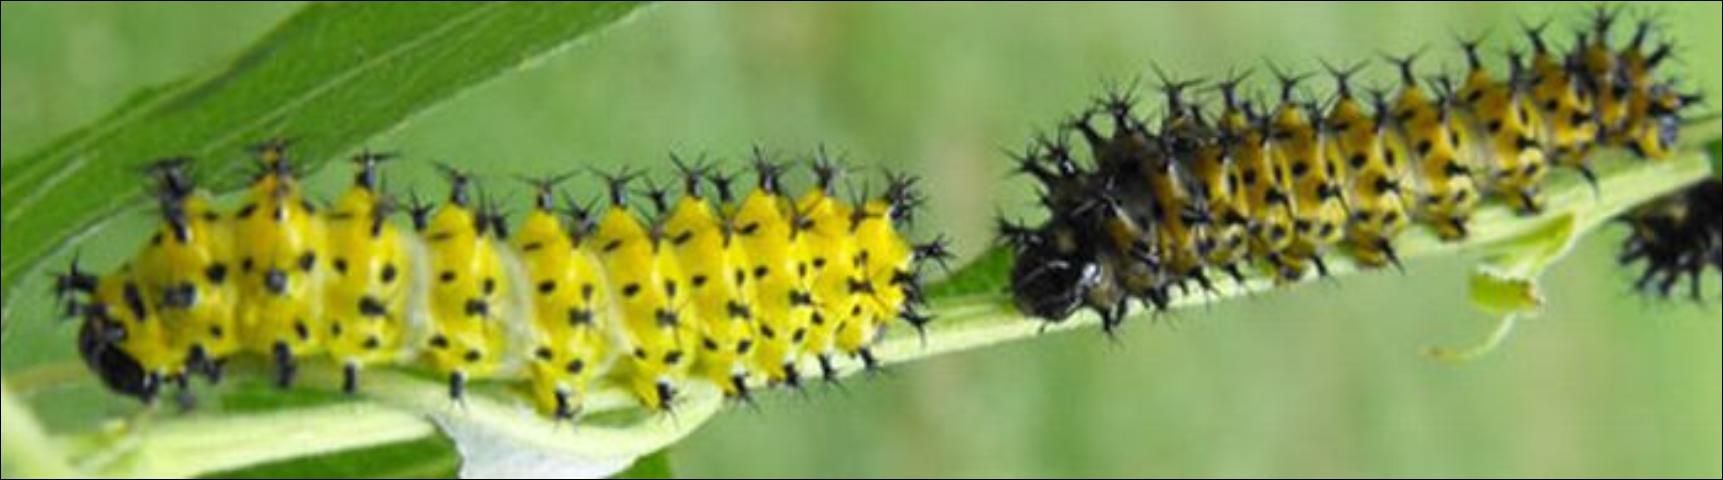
55;141;949;420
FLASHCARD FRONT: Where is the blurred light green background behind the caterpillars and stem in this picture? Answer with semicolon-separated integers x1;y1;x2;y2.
10;2;1723;477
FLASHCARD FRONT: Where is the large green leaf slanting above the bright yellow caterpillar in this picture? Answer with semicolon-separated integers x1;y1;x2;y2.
0;2;639;326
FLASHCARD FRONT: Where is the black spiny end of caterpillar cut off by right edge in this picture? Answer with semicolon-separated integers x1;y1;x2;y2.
1616;177;1723;301
